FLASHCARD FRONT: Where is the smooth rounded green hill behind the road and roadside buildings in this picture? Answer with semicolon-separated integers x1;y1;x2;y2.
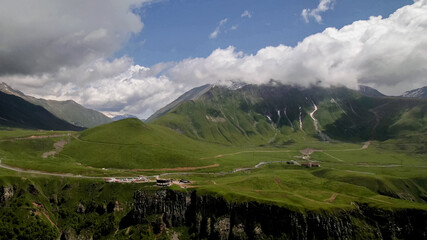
61;118;226;169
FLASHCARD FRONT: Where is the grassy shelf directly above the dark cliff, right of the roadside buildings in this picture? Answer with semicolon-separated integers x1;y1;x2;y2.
167;164;427;210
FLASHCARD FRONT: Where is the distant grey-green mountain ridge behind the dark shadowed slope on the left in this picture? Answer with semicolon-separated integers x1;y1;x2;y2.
0;83;112;128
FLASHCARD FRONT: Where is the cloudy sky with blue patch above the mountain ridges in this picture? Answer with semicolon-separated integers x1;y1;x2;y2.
0;0;427;118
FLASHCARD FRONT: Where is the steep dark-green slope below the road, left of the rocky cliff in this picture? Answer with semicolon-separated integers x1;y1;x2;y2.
0;173;159;239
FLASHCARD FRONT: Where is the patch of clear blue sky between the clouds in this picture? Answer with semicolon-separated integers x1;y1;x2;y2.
115;0;412;66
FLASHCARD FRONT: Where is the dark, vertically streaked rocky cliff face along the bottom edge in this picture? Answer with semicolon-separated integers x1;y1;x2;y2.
129;189;427;239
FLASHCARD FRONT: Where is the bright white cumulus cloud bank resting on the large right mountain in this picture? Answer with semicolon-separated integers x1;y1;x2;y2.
168;0;427;94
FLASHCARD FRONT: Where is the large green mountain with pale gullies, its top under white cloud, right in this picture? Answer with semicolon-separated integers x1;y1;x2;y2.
152;83;427;146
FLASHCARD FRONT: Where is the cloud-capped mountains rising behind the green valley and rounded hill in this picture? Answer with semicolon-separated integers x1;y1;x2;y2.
0;82;427;136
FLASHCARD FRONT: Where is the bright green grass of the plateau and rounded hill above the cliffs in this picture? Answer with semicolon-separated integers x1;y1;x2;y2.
0;119;427;212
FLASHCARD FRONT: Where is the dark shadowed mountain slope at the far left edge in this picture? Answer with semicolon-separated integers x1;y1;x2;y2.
0;92;83;131
